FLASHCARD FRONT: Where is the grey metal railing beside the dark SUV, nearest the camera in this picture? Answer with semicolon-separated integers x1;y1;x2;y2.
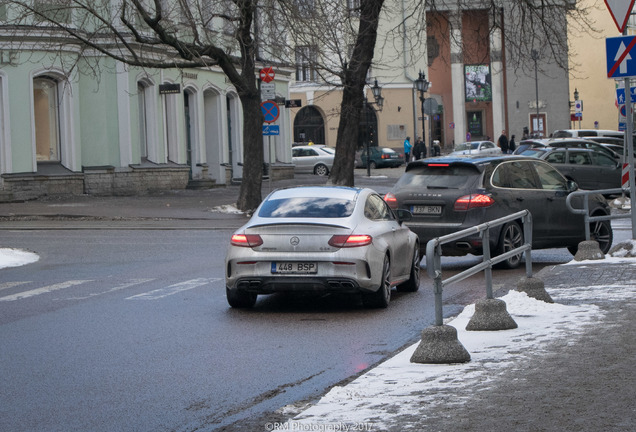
426;210;532;326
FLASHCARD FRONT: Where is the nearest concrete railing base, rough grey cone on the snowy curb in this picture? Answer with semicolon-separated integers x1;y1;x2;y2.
411;325;470;364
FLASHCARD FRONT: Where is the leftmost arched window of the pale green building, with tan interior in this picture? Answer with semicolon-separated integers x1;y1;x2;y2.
33;76;61;162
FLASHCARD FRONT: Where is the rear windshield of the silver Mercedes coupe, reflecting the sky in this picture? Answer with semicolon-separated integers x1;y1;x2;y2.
258;197;354;218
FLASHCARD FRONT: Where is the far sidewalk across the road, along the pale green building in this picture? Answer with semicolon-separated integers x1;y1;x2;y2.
0;167;404;229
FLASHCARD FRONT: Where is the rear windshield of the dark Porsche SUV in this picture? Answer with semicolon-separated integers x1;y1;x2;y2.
396;166;480;189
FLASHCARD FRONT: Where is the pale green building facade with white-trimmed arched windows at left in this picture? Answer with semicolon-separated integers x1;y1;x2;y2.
0;5;291;200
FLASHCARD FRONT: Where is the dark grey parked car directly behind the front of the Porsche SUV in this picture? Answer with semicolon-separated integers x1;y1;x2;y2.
538;148;622;190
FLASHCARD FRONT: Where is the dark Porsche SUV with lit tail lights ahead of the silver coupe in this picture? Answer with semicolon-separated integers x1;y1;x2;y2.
384;155;613;268
